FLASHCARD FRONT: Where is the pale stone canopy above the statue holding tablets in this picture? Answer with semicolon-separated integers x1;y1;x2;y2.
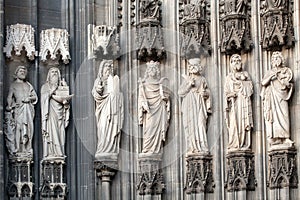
88;24;120;59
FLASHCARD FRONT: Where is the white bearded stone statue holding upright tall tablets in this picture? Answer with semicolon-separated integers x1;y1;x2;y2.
92;60;124;158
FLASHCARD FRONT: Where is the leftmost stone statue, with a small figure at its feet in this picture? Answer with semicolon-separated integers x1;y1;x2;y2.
5;66;38;157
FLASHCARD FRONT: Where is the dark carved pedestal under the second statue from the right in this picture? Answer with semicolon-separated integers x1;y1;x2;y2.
225;151;256;192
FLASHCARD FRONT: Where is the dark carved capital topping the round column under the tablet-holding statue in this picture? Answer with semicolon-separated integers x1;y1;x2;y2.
94;160;118;181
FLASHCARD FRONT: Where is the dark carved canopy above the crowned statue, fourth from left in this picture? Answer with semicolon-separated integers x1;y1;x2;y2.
136;0;166;61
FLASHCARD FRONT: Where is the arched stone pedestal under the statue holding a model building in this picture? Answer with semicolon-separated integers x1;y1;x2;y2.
40;158;67;200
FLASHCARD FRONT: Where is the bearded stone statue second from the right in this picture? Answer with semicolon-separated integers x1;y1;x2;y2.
224;54;253;151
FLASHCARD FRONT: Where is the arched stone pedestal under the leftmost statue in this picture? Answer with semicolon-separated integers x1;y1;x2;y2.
7;157;34;200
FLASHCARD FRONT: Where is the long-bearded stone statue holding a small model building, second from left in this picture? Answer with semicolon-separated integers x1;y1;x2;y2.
41;67;73;159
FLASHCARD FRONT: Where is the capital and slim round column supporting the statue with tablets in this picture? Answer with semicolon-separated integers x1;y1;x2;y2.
94;156;118;200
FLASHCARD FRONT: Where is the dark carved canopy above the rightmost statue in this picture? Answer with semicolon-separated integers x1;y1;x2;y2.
260;0;295;50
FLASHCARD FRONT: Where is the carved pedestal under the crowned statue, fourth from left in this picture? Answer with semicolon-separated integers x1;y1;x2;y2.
137;153;166;199
